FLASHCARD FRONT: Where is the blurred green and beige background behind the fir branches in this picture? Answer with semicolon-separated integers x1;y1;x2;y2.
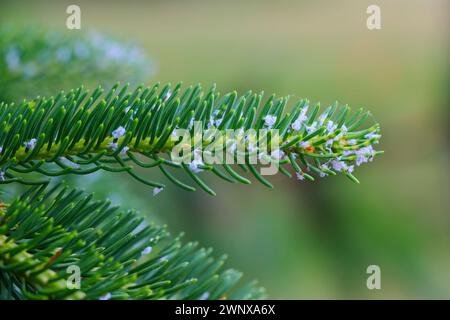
0;0;450;299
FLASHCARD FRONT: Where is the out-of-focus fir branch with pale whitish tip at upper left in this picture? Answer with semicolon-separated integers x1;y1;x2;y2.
0;26;156;101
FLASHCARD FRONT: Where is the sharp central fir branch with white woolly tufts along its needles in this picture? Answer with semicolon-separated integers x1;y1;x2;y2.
0;84;380;194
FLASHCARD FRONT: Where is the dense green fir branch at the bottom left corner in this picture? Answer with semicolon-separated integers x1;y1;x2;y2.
0;186;264;299
